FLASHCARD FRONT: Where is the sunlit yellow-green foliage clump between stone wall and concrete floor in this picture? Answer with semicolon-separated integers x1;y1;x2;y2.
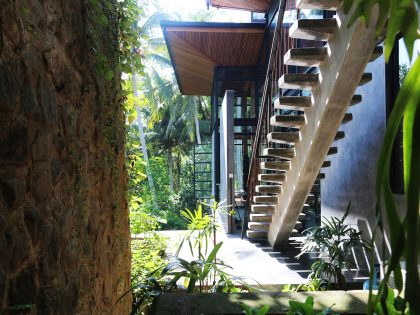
126;203;252;314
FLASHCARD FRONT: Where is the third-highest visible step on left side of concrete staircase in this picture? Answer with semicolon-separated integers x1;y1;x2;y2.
284;47;327;67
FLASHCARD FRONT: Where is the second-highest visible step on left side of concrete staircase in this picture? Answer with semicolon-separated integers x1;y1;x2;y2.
289;18;337;41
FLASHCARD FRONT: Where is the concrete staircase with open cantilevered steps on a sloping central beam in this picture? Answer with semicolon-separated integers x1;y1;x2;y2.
247;0;382;247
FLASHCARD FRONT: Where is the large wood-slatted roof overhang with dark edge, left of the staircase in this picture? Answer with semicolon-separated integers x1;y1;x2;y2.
161;21;265;95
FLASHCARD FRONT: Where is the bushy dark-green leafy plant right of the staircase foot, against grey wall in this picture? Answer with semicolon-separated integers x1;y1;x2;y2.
297;202;372;290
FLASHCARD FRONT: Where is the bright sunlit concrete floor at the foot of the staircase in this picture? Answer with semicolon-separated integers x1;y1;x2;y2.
160;231;310;289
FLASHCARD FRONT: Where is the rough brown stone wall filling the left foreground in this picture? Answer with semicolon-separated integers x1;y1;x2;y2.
0;0;131;314
